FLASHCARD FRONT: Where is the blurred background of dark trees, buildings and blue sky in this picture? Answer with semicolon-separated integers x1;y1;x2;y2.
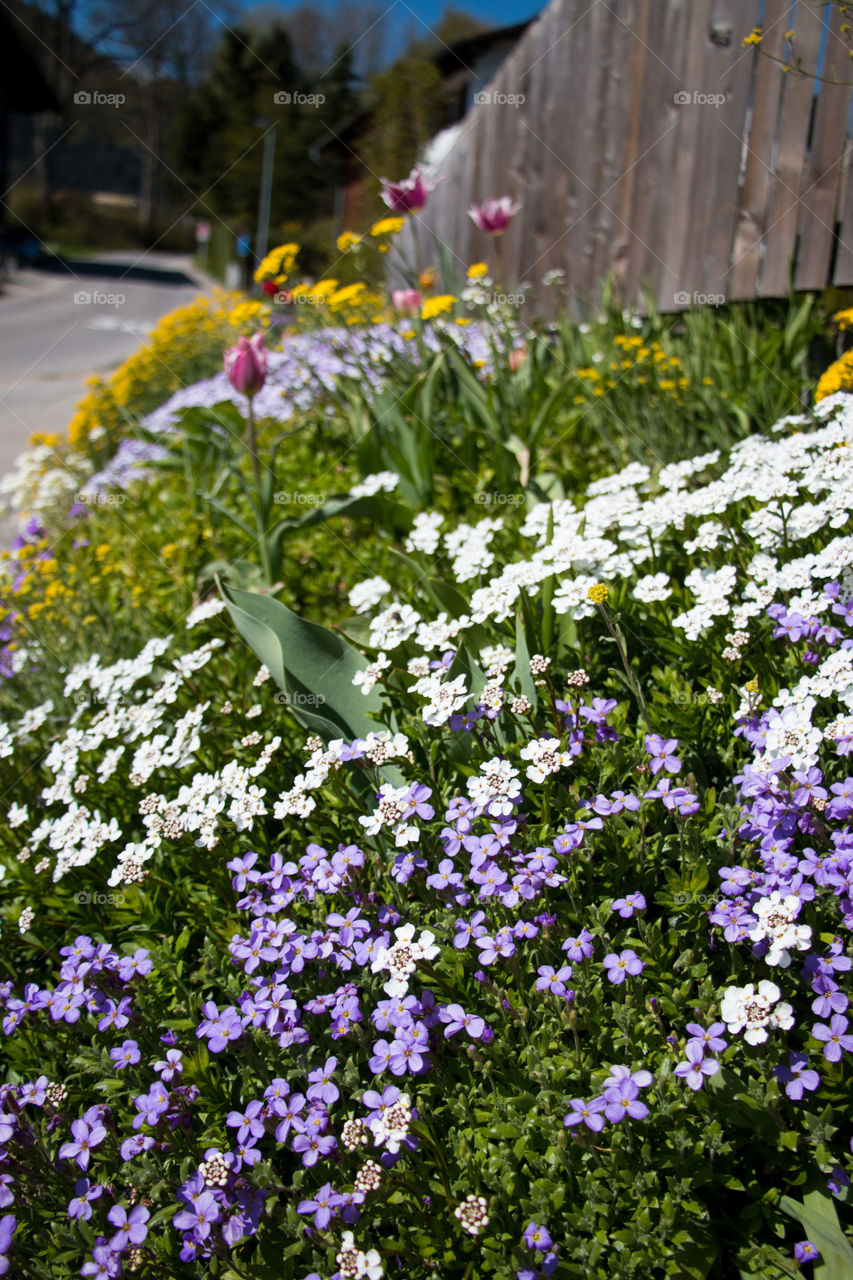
0;0;539;285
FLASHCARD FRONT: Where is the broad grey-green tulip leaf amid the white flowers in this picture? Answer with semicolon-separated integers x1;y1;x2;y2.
219;582;380;741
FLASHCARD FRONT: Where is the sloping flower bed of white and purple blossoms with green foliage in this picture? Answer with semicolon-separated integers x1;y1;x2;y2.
0;225;853;1280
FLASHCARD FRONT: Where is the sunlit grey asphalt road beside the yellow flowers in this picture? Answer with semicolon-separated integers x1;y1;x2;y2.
0;252;211;475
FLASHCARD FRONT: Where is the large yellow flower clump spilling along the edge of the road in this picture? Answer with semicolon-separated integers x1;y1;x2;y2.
68;289;264;449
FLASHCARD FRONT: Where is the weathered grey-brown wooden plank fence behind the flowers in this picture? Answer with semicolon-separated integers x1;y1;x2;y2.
401;0;853;314
